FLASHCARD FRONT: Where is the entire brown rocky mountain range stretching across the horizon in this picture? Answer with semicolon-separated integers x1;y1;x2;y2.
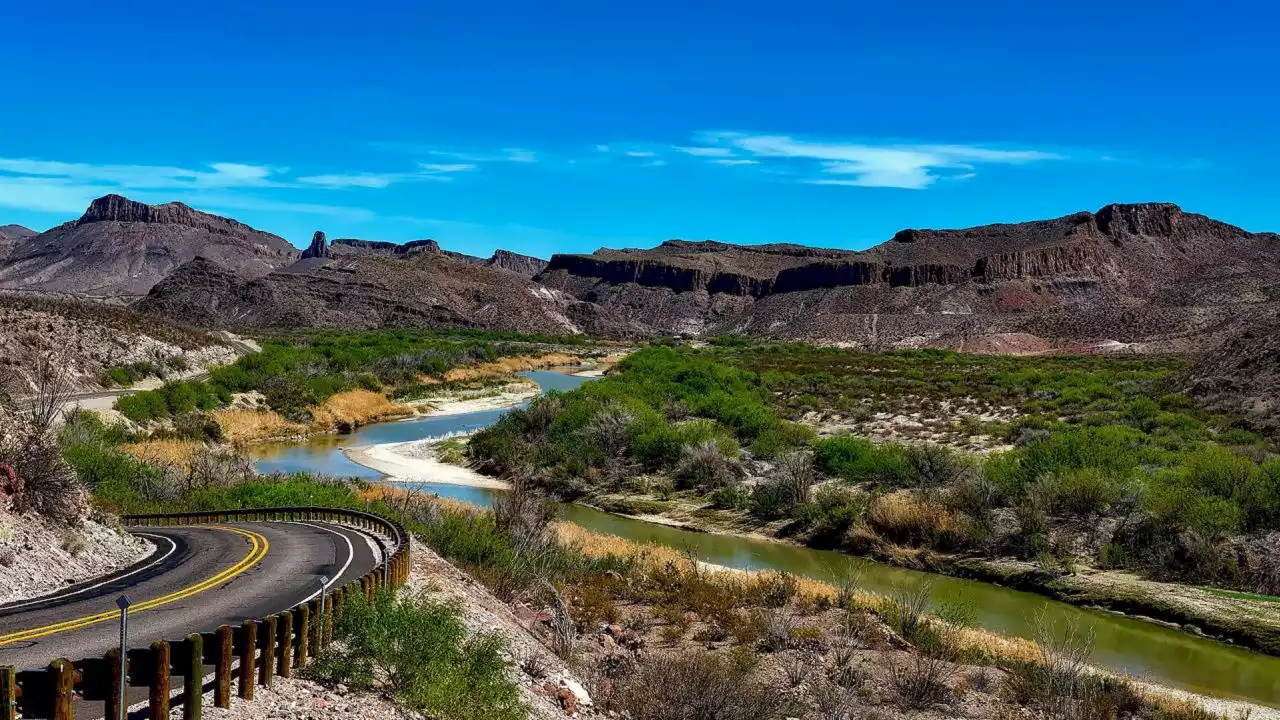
0;196;1280;354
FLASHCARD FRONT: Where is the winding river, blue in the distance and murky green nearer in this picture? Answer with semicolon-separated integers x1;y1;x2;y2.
252;370;1280;707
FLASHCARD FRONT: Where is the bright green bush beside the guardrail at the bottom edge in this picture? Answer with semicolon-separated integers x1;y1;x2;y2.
307;588;526;720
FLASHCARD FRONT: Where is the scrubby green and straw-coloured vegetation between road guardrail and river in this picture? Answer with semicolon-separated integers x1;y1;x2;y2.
7;338;1259;720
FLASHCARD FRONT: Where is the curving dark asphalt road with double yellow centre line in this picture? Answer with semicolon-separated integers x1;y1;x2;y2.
0;523;379;669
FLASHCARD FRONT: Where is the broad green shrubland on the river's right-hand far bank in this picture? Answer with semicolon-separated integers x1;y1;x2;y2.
470;341;1280;651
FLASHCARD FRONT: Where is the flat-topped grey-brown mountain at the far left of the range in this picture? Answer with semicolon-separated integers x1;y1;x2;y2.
0;195;298;299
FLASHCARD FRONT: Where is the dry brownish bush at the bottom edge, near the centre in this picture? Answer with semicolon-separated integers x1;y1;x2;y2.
617;652;790;720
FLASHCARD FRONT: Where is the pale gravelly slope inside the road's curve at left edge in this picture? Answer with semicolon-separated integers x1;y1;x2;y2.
0;507;154;603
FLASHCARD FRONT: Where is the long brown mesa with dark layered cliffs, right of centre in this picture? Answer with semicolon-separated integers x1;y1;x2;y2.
535;204;1280;351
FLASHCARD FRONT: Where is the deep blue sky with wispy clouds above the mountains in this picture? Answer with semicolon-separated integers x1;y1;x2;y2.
0;0;1280;256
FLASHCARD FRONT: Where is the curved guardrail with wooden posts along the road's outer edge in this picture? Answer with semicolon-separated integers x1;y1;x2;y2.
0;507;410;720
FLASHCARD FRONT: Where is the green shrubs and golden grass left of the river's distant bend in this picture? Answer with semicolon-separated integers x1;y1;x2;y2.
109;331;596;442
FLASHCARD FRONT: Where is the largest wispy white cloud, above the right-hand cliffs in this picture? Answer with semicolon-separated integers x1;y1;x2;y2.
690;132;1066;190
